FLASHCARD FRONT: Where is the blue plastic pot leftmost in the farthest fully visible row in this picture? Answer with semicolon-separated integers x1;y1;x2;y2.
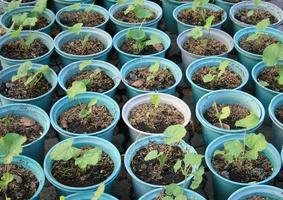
0;6;55;35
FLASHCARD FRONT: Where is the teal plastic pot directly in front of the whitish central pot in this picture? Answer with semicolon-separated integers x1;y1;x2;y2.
124;135;199;198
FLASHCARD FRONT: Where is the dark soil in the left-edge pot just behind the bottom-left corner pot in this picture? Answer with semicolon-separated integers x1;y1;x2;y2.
0;115;43;143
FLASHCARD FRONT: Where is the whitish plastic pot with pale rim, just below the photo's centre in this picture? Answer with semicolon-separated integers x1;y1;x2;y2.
122;93;191;141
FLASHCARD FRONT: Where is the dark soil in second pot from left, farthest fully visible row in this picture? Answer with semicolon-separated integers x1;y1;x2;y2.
59;11;105;27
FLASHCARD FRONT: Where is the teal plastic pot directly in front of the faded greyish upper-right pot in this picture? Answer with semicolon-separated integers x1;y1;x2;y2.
186;57;249;104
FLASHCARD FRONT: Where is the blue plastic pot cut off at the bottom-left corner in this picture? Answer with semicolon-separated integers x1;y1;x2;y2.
0;155;45;200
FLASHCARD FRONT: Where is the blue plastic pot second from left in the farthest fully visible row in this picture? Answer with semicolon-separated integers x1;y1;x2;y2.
56;4;109;31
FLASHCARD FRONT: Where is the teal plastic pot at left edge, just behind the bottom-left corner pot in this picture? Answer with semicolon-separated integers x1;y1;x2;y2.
0;103;50;163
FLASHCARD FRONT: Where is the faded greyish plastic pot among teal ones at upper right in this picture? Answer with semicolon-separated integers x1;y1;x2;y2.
177;28;234;70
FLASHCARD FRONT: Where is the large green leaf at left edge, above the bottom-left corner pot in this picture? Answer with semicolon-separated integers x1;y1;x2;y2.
0;133;27;164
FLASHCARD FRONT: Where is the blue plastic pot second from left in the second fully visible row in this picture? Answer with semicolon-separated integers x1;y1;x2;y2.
54;28;112;66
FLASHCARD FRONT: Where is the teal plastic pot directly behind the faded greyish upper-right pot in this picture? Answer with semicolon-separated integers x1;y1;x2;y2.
173;3;227;34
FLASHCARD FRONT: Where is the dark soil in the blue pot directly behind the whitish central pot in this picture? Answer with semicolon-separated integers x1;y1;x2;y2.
126;67;175;91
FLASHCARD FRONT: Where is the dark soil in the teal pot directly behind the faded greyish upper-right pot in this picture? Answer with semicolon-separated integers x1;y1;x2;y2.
177;8;223;26
